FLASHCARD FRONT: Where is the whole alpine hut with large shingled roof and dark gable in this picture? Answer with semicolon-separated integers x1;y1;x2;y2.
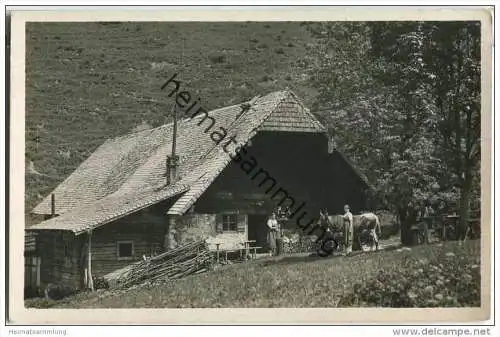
26;91;369;288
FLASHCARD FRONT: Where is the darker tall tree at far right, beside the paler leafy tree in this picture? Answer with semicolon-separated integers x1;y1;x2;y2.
372;22;481;239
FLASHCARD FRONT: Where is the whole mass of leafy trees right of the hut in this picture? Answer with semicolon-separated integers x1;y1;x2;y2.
309;22;480;243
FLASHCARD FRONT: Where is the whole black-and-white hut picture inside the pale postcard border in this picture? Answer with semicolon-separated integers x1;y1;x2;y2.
6;5;492;326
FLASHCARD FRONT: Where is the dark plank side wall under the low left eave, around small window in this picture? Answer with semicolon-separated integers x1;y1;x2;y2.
37;202;166;288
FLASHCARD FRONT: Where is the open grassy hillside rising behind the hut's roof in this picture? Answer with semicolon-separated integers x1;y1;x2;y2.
26;22;315;215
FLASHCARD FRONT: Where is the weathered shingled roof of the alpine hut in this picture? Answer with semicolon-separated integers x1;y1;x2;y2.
28;91;336;234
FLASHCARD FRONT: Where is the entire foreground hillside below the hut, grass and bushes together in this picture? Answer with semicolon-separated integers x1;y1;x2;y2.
26;241;480;308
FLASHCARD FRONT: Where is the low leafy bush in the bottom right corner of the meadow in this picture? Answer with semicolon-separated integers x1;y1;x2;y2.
339;249;481;307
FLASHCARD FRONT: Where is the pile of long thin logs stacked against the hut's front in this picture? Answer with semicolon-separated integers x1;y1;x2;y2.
118;241;213;288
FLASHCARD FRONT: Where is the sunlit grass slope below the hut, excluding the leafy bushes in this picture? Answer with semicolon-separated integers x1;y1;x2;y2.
37;241;480;308
